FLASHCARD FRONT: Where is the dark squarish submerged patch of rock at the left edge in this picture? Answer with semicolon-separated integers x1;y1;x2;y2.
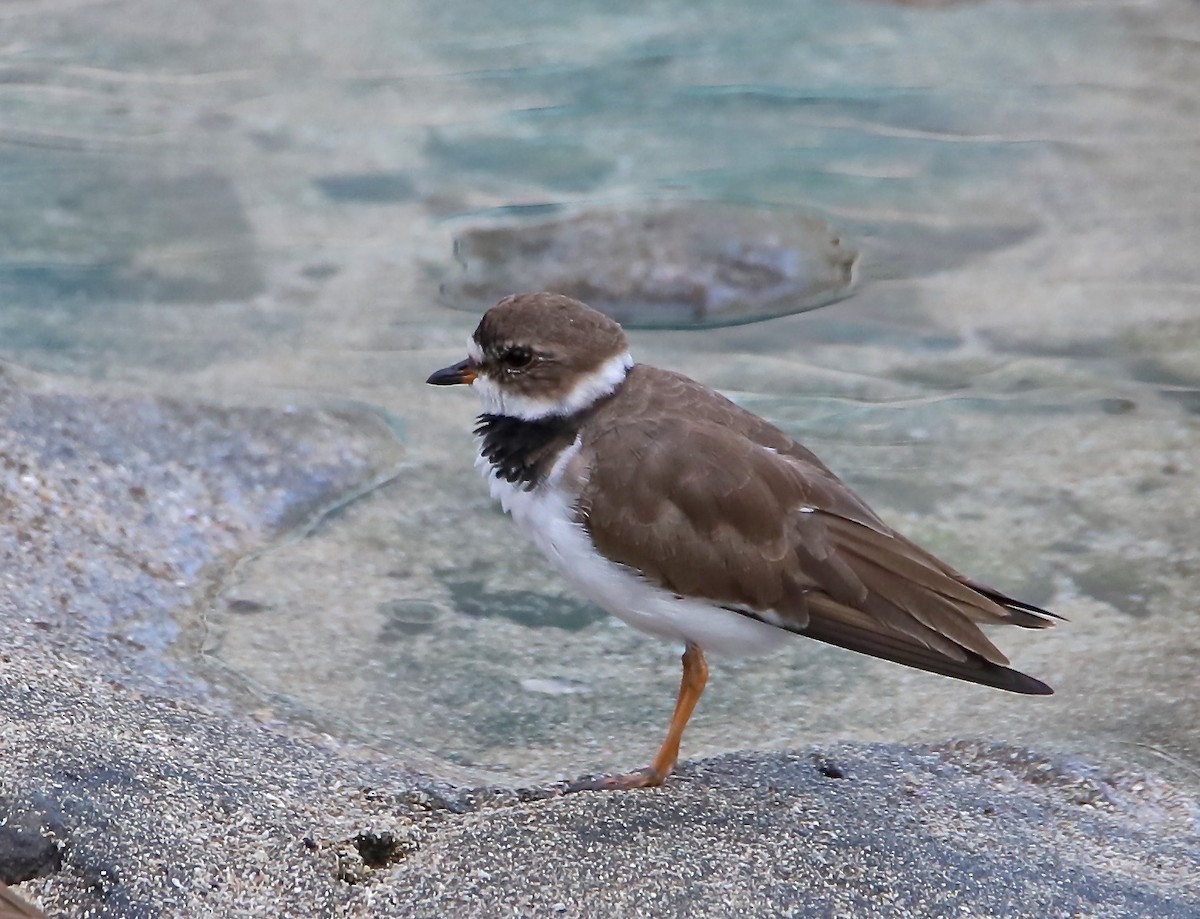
0;150;264;308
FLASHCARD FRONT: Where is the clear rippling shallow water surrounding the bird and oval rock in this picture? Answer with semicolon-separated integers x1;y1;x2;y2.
0;0;1200;780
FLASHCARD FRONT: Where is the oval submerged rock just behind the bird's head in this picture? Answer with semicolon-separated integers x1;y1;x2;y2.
442;203;858;329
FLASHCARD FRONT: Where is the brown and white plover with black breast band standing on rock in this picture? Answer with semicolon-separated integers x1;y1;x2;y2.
427;293;1060;791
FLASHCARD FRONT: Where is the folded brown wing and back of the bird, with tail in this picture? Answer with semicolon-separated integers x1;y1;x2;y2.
580;368;1050;692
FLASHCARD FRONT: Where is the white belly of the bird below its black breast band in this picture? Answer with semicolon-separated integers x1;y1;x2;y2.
475;442;786;655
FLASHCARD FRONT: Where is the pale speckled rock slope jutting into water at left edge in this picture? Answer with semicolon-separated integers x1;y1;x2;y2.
0;366;400;700
